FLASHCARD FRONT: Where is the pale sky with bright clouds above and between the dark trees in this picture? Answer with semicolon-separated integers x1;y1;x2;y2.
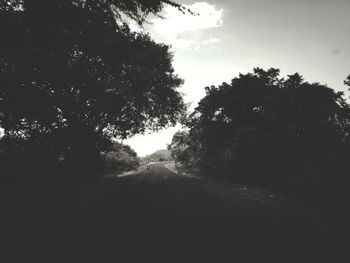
123;0;350;156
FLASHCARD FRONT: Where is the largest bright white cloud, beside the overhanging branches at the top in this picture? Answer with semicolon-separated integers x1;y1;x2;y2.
148;2;223;48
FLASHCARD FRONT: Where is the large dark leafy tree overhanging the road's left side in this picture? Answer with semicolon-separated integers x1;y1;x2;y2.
0;0;186;177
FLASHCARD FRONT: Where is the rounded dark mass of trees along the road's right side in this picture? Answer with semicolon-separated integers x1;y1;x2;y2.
169;68;350;213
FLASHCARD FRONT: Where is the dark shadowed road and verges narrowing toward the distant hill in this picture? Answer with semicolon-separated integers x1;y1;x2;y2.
1;163;350;263
